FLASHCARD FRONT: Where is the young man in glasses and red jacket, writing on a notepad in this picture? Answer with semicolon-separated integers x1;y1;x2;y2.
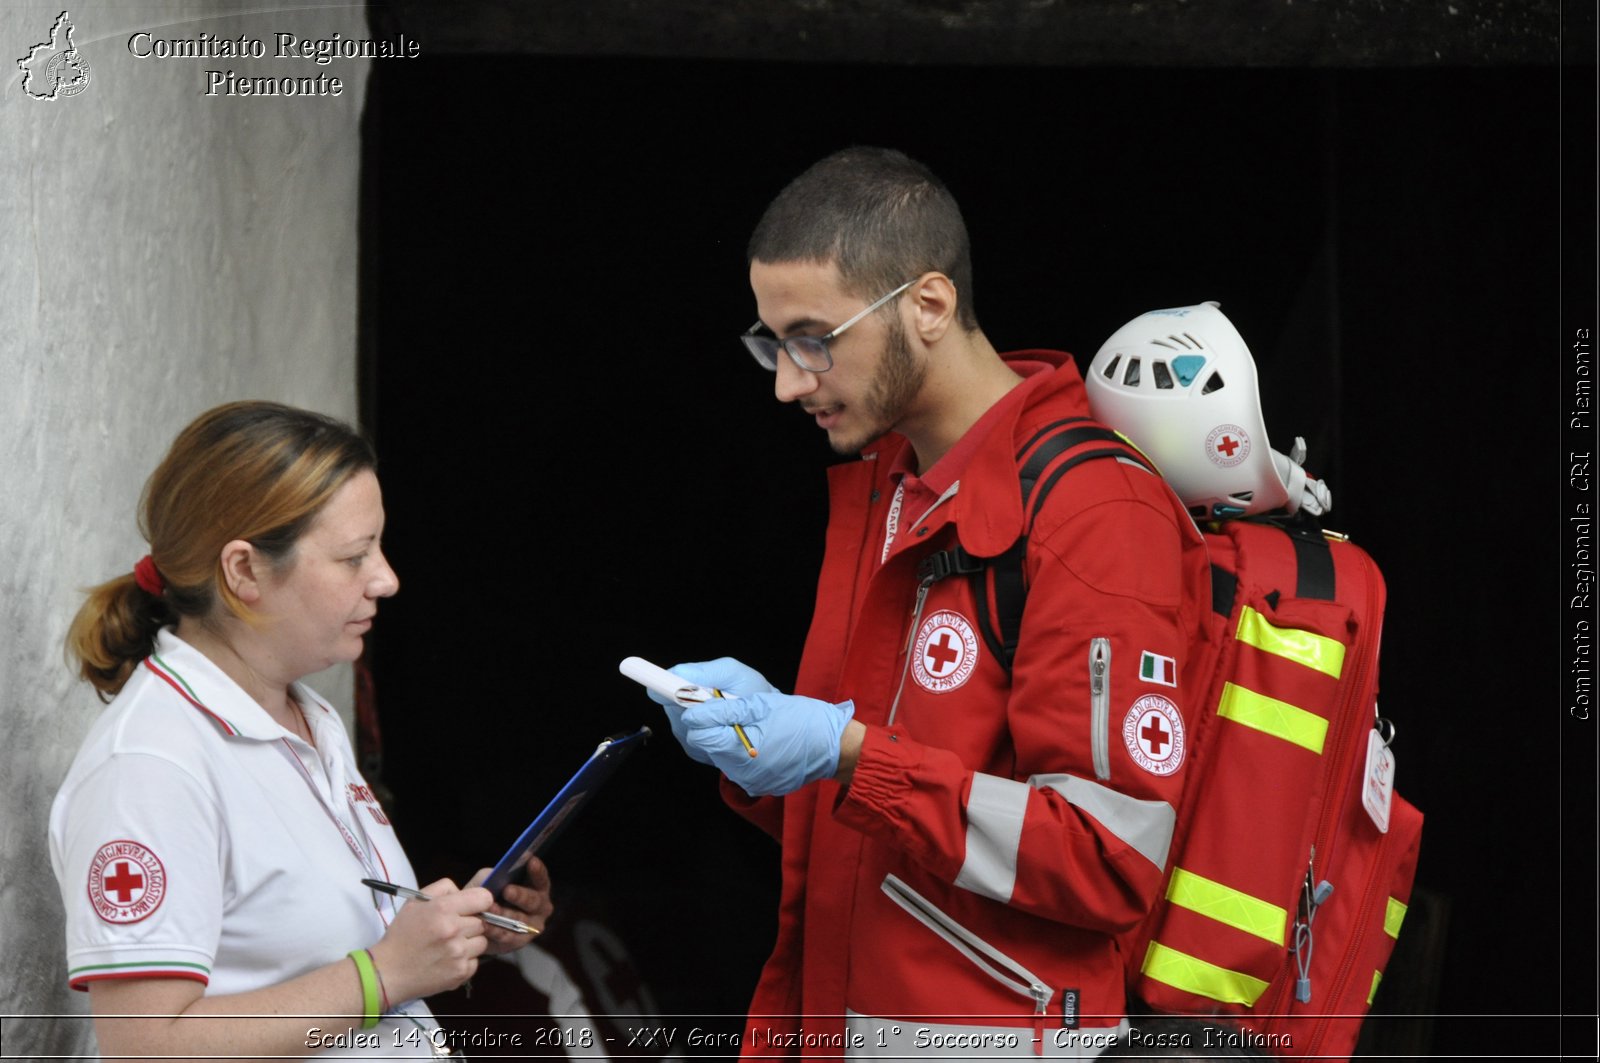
649;149;1210;1057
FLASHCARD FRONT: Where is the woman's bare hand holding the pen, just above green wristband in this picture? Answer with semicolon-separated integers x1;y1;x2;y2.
371;879;489;1004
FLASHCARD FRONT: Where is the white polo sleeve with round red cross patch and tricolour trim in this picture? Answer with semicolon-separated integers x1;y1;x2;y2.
50;752;226;989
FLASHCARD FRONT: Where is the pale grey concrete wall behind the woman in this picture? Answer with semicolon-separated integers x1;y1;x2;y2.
0;0;370;1057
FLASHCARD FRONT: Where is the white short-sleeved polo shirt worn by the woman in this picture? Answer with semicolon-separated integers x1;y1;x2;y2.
50;631;443;1058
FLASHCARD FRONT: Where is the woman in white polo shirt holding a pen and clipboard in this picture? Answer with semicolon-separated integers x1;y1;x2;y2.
50;402;550;1057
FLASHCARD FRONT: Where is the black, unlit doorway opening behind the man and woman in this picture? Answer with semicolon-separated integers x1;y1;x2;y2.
363;40;1594;1057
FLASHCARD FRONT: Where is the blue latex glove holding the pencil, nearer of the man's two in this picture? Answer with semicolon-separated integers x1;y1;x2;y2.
680;692;856;797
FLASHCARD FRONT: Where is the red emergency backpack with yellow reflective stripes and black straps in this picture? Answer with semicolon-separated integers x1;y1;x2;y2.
946;418;1422;1058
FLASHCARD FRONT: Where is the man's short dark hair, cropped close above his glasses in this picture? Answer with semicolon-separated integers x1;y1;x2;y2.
749;147;978;330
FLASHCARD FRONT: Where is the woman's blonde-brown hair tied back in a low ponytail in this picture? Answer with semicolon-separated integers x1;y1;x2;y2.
67;402;378;700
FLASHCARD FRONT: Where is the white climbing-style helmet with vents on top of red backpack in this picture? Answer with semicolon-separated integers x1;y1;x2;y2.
1083;303;1333;520
